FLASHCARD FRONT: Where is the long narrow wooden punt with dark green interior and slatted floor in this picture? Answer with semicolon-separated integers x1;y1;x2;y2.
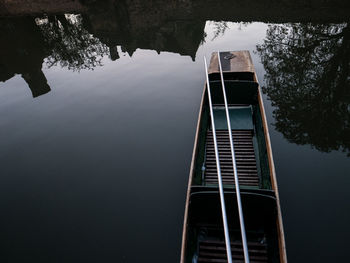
180;51;287;263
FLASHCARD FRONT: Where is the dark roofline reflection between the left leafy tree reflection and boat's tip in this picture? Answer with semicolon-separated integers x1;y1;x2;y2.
84;1;205;60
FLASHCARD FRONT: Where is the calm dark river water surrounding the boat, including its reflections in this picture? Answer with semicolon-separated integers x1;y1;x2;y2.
0;1;350;263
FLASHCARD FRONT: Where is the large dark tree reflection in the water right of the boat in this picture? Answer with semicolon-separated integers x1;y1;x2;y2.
257;23;350;154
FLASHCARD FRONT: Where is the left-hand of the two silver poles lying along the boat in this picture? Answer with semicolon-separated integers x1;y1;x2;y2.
204;57;232;263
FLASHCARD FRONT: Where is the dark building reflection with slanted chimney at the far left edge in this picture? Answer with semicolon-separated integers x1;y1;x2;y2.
0;17;50;97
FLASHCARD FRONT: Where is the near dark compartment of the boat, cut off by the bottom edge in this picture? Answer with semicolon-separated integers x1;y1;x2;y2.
186;191;280;263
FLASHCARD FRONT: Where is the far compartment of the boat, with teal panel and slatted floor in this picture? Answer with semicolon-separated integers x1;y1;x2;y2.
192;74;271;190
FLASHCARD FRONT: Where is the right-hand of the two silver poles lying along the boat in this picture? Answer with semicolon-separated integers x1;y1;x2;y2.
218;52;249;263
